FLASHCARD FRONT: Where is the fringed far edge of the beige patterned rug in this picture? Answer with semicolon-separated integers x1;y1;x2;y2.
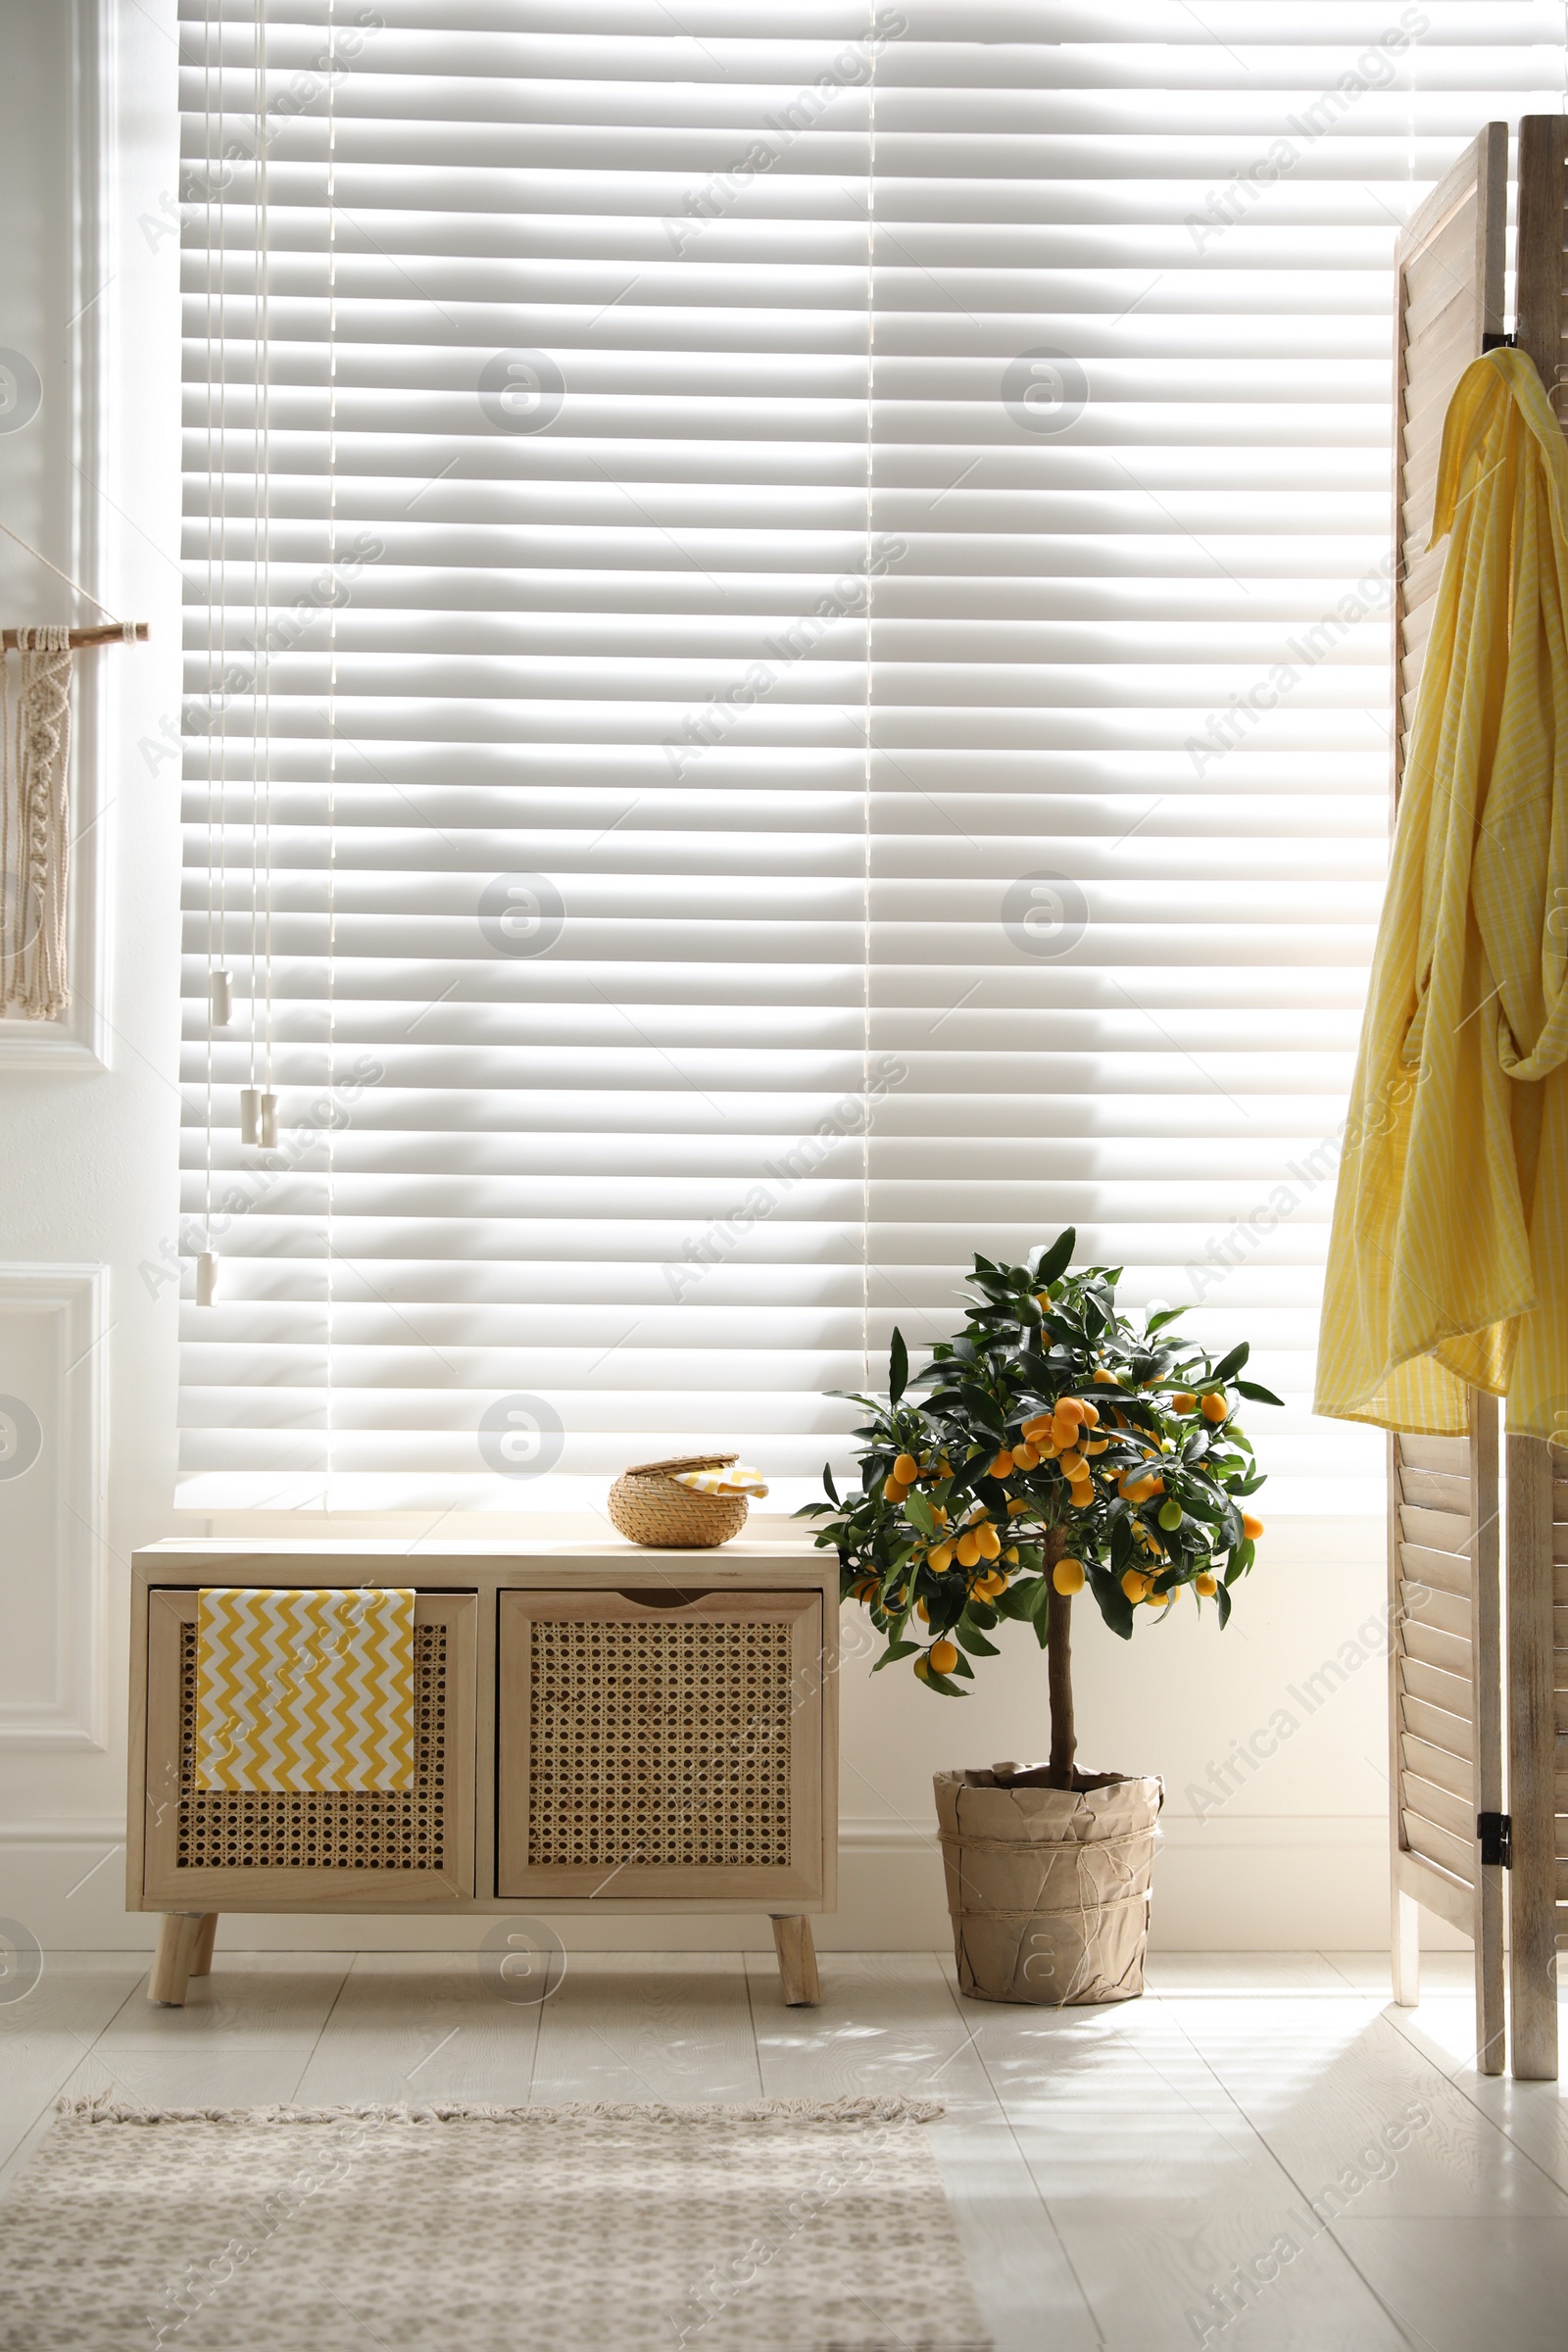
54;2091;948;2124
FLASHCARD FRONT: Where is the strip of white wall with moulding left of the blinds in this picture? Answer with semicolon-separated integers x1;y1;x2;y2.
0;0;178;1942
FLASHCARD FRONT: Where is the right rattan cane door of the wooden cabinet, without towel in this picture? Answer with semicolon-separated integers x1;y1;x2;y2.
496;1590;823;1910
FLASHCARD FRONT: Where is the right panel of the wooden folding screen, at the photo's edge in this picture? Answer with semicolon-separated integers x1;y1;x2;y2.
1507;116;1568;2082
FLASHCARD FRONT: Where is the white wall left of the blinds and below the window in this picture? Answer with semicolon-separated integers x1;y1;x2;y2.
0;0;1455;1950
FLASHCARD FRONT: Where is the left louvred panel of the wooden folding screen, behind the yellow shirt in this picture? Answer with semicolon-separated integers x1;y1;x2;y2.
1390;122;1507;2075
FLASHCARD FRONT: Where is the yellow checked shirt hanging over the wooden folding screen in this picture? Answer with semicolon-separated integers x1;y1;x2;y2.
1316;351;1568;1440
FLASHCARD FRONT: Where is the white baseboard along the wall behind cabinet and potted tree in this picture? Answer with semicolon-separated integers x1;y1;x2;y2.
0;1813;1467;1952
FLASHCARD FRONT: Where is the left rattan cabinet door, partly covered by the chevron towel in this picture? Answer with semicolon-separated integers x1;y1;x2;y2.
143;1590;479;1910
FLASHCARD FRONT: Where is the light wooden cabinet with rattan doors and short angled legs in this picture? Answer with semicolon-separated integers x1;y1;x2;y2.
127;1534;839;2004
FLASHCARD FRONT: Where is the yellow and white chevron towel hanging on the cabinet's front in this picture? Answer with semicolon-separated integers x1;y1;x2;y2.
195;1586;414;1789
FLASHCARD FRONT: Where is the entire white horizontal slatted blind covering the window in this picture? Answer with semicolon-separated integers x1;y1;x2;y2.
177;0;1563;1510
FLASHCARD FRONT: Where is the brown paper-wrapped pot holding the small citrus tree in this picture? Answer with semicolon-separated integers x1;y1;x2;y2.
936;1766;1166;2009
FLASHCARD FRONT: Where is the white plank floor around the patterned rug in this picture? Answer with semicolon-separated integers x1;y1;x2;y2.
0;1922;1568;2352
